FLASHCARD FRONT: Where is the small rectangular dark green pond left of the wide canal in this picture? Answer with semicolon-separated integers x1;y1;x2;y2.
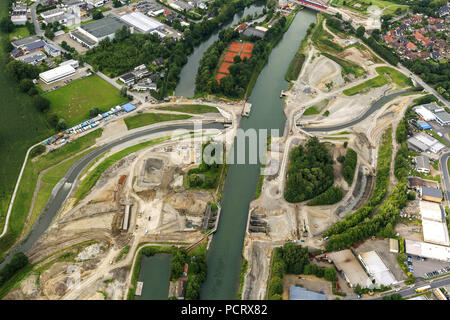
136;253;172;300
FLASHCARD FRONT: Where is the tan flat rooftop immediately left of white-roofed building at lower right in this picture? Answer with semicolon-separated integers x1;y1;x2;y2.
327;249;372;288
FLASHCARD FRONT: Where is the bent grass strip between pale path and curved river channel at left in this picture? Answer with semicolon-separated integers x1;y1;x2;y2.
0;129;102;256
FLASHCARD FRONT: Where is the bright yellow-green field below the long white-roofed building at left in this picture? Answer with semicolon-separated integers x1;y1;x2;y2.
43;75;128;127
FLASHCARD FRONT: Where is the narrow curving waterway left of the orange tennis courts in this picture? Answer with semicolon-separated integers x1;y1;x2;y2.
175;3;264;98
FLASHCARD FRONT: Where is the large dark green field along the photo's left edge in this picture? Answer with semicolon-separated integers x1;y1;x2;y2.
0;1;53;248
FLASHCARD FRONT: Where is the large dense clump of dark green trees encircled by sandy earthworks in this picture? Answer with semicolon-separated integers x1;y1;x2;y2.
284;137;334;202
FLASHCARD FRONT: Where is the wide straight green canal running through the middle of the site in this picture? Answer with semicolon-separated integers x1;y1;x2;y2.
201;10;316;299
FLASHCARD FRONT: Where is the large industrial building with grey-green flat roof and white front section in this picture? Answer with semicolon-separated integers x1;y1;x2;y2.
69;15;130;49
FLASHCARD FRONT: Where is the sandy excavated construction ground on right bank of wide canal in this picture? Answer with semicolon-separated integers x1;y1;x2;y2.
242;16;420;300
